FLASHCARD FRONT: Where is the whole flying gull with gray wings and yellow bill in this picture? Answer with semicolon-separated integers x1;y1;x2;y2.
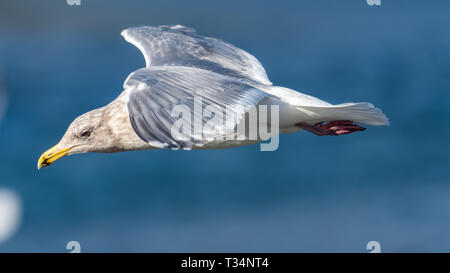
38;25;388;168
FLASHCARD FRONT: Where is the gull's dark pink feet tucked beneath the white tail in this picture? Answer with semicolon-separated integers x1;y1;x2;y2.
295;120;366;136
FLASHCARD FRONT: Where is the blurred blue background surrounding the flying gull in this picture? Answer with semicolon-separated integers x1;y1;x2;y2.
0;0;450;252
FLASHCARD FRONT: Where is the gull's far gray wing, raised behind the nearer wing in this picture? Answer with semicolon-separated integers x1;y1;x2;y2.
121;25;272;85
